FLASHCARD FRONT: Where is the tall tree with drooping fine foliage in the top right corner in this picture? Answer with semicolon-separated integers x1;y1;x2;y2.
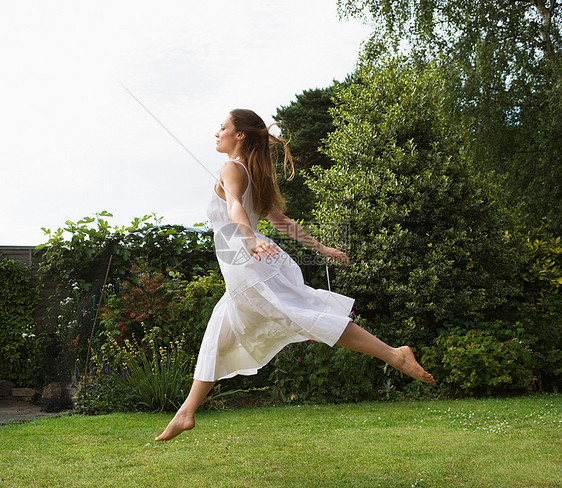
338;0;562;233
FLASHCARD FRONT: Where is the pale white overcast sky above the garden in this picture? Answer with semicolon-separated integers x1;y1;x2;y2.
0;0;369;246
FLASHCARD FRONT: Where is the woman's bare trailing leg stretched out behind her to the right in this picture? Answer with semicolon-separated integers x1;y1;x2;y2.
336;322;435;385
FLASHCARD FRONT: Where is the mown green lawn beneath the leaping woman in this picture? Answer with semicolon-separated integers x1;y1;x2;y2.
0;395;562;488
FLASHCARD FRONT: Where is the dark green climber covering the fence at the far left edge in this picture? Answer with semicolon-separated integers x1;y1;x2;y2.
0;259;45;387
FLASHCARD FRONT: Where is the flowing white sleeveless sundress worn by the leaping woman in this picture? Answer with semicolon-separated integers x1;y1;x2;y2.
190;160;354;381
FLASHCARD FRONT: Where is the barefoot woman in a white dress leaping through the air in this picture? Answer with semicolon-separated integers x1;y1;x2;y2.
156;109;435;441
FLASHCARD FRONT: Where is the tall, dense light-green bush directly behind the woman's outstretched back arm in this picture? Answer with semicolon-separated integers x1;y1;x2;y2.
310;59;517;344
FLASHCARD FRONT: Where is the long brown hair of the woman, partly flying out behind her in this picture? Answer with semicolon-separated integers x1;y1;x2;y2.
230;108;295;217
